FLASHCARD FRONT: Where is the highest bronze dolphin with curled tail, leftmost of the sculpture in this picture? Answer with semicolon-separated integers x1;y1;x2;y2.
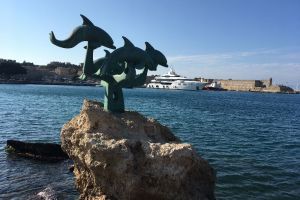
50;15;116;49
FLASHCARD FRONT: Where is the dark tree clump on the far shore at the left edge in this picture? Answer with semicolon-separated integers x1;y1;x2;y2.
0;59;27;75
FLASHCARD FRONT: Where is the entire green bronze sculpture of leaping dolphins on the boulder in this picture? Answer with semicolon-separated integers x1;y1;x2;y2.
50;15;168;112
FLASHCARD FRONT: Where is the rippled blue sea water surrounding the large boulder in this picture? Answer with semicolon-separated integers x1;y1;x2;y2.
0;85;300;200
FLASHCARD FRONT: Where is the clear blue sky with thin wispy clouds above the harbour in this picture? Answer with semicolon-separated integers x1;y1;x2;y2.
0;0;300;87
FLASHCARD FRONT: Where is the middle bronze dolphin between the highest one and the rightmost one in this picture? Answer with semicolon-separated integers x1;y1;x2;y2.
98;36;155;76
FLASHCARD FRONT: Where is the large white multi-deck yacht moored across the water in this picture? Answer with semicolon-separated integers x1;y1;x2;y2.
147;68;206;90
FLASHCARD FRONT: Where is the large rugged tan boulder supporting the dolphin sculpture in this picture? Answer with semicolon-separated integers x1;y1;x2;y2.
61;100;215;199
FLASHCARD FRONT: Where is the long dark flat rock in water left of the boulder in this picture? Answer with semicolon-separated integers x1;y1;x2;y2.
6;140;69;161
